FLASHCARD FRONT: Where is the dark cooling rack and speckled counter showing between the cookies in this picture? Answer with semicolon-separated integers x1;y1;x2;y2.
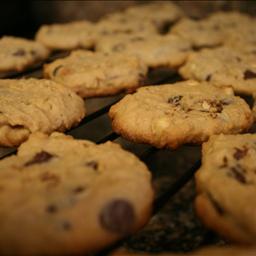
0;53;224;255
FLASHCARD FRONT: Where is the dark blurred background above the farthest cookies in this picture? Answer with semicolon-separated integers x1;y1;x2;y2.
0;0;256;38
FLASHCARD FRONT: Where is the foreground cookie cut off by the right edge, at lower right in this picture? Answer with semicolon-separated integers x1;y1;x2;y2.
196;134;256;244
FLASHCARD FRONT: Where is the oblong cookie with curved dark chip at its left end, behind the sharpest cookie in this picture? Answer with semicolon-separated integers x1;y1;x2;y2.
44;50;147;97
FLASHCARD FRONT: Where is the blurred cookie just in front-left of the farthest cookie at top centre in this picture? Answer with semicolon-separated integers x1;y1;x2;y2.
95;12;157;36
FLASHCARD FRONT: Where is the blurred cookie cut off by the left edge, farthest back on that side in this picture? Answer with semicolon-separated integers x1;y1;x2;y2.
0;36;49;73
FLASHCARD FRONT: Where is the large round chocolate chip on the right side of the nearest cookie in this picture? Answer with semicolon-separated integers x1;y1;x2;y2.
99;199;135;235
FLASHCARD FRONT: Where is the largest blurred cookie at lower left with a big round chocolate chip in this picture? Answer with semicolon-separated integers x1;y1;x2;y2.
0;133;153;255
